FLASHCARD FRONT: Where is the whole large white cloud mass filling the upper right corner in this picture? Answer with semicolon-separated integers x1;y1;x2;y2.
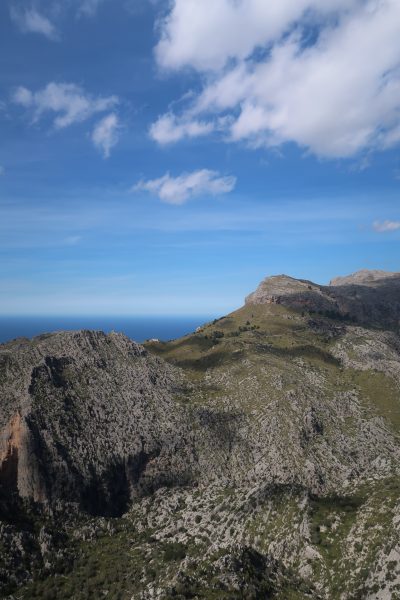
151;0;400;158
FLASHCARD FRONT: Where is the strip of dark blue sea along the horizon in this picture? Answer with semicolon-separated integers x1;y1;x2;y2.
0;315;214;343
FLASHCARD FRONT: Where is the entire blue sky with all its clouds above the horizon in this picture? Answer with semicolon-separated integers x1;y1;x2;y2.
0;0;400;316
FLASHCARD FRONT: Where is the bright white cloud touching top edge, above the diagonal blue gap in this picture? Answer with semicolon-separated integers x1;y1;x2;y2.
156;0;360;71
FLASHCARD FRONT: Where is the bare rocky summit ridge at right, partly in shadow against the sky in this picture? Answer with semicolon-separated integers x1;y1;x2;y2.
246;270;400;329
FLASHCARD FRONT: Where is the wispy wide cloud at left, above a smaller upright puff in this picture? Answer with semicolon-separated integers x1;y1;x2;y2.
13;82;118;129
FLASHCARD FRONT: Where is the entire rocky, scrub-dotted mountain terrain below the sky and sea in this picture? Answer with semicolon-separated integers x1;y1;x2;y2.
0;271;400;600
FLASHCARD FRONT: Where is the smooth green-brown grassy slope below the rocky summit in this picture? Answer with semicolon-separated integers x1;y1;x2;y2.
146;304;400;434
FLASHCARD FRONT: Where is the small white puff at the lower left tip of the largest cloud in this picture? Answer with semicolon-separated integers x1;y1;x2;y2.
150;114;213;145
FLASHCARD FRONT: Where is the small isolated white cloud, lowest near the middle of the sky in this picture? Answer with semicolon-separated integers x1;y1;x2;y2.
133;169;236;204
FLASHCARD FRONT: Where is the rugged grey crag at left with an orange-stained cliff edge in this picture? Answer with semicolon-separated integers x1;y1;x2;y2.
0;331;194;514
